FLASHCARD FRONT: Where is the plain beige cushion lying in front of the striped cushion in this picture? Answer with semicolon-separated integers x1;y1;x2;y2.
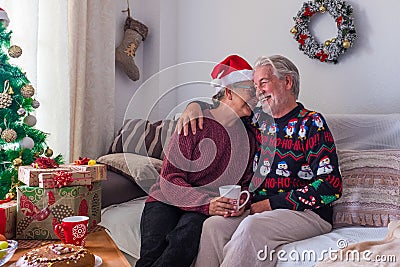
97;153;162;192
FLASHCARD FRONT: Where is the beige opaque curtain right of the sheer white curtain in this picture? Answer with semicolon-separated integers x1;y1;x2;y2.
68;0;115;159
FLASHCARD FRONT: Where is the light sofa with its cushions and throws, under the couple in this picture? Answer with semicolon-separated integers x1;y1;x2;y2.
99;114;400;266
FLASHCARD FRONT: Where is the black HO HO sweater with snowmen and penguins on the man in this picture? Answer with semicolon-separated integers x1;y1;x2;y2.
252;103;342;223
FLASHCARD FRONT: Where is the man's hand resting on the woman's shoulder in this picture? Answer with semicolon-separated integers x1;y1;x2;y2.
175;102;203;136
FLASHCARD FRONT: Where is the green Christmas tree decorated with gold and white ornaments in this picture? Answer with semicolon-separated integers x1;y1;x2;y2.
0;8;62;200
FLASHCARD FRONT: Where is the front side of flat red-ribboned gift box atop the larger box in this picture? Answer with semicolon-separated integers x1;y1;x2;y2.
39;171;92;188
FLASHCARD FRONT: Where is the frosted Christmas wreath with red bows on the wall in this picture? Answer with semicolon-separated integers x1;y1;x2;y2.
290;0;356;64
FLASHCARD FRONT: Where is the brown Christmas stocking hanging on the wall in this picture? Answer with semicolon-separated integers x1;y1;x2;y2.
115;9;148;81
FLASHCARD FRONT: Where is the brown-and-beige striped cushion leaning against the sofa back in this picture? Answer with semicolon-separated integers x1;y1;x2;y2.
109;119;176;160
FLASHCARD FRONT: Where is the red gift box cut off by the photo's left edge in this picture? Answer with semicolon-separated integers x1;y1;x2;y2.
0;200;17;239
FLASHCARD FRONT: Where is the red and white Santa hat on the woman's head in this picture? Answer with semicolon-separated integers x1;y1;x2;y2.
211;55;254;92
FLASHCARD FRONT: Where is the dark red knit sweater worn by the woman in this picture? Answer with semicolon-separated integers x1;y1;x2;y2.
146;110;256;215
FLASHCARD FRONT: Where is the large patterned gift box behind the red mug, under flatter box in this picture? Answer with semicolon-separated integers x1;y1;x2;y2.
16;182;101;239
